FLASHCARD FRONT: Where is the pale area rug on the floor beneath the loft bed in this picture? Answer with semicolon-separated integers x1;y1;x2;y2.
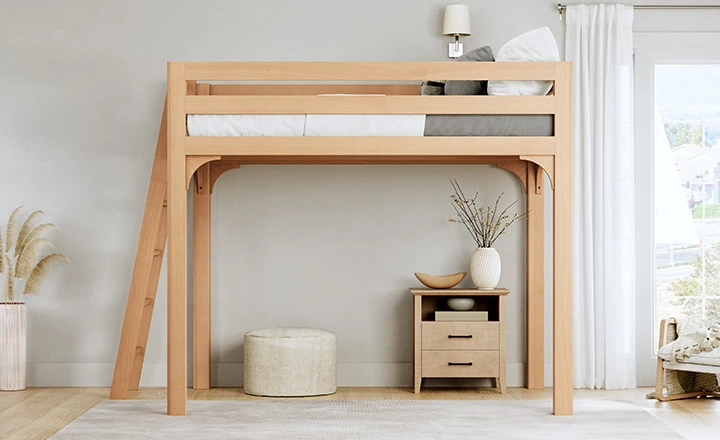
52;400;683;440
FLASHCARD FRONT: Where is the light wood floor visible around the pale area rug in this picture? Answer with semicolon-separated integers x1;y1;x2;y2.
0;388;720;440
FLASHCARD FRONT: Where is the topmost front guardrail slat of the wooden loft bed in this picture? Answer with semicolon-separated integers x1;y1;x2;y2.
185;61;557;81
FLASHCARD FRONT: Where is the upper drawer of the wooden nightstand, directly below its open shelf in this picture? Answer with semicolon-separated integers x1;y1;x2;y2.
422;322;500;350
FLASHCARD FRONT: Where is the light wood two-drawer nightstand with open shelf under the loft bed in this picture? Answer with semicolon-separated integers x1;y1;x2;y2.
410;288;510;394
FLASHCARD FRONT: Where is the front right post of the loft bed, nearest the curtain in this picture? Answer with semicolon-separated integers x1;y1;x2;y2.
553;63;573;415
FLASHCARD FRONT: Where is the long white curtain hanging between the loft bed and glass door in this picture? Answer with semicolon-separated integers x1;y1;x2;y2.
565;5;635;389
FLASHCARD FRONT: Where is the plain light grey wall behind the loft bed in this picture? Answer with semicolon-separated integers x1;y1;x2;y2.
0;0;714;385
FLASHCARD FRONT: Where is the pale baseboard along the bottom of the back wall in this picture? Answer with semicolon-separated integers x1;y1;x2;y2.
27;362;552;387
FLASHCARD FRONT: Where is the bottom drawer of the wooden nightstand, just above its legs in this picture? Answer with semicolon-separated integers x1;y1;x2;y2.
422;350;500;377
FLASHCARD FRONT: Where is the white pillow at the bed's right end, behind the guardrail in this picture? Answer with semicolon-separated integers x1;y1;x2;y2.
488;27;560;95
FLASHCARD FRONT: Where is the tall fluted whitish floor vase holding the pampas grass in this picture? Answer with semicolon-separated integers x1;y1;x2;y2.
0;303;25;391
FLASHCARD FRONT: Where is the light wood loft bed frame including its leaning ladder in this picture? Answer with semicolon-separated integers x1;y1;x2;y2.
110;62;573;415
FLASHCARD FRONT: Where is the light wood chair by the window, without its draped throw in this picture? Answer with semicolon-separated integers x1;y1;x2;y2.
648;318;720;402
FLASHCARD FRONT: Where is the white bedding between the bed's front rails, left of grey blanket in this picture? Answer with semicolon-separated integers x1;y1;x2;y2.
187;115;425;136
